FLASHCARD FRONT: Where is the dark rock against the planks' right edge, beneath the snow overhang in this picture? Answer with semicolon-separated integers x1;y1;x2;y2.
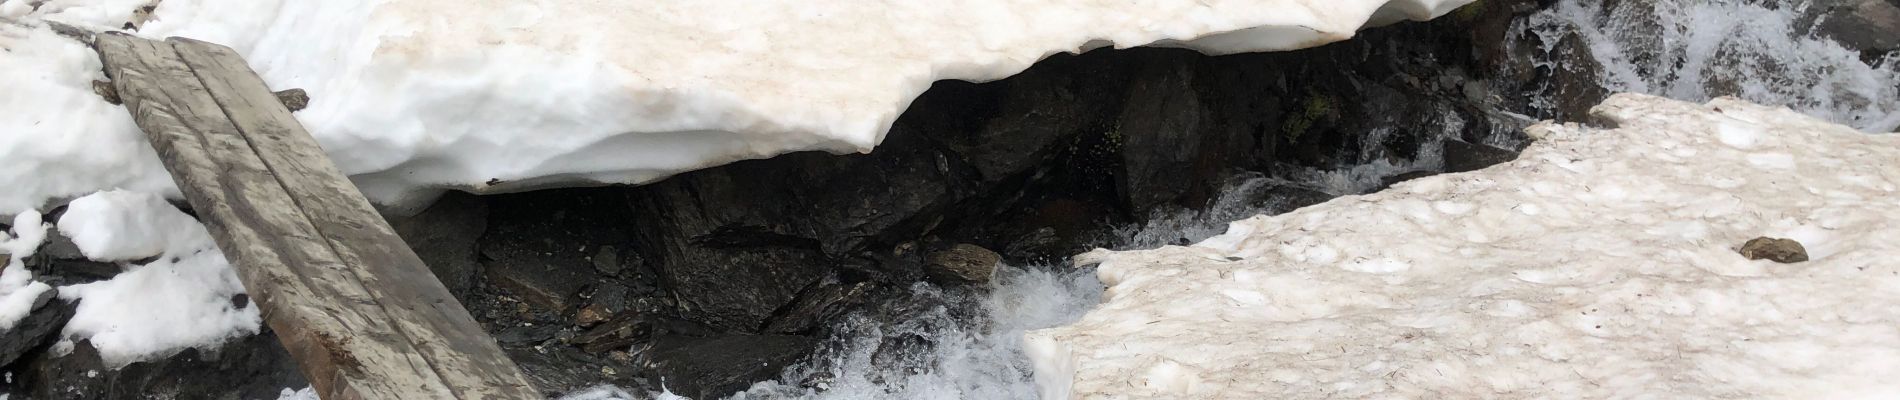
386;193;488;300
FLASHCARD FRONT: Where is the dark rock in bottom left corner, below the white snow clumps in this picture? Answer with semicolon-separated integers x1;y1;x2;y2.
8;330;310;400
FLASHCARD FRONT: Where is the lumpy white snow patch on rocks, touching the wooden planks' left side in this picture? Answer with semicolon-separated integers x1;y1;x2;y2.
57;191;262;368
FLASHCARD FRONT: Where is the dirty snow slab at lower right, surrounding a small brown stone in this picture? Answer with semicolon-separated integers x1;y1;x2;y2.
1026;95;1900;398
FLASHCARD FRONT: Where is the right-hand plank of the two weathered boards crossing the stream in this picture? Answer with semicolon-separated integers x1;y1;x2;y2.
169;38;538;398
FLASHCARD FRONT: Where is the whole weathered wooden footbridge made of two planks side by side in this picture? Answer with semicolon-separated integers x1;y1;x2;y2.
95;34;538;400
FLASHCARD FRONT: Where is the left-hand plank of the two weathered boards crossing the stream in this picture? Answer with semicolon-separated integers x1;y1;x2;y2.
95;34;482;400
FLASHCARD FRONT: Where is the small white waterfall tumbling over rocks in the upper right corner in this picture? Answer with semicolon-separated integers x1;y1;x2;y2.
1518;0;1900;133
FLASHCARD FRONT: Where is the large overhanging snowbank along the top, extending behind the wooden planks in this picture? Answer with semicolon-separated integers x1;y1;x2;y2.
0;0;1471;212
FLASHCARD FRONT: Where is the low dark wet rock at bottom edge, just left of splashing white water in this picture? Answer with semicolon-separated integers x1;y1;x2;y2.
640;334;819;398
